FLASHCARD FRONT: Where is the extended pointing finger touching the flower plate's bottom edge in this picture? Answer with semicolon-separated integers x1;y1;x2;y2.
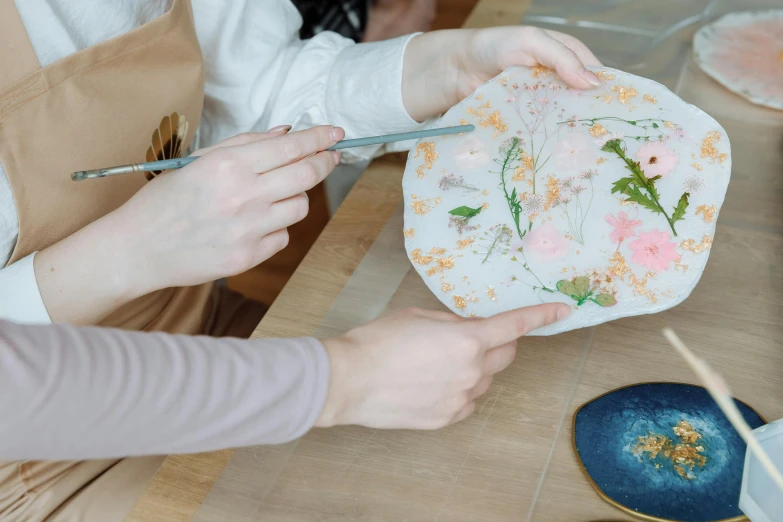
464;303;571;350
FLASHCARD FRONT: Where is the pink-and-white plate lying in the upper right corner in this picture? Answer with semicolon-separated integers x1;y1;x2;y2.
693;9;783;109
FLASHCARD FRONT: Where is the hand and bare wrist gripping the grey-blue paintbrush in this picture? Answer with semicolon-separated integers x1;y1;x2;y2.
35;126;344;324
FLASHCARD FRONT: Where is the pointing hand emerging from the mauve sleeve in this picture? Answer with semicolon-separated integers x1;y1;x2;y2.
316;304;571;429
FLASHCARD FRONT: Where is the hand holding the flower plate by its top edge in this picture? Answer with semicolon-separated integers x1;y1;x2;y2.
402;26;601;121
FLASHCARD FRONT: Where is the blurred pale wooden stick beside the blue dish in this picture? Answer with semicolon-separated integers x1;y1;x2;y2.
663;328;783;492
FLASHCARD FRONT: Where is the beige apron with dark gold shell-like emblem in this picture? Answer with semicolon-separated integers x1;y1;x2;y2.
0;0;263;522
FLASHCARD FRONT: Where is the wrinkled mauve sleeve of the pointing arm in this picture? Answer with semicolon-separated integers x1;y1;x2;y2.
0;321;329;460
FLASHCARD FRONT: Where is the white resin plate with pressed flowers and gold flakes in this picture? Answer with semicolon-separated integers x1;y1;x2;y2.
403;67;731;335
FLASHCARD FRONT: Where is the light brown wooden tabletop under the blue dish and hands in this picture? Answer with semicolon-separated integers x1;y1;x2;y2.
129;0;783;522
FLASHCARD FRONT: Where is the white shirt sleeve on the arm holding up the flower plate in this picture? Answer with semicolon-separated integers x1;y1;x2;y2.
193;0;423;162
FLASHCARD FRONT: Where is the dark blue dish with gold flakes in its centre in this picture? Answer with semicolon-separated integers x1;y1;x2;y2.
573;383;765;522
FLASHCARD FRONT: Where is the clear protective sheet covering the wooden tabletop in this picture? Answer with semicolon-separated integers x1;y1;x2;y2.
194;0;783;522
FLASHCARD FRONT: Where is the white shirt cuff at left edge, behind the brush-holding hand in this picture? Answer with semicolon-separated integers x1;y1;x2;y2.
0;252;52;324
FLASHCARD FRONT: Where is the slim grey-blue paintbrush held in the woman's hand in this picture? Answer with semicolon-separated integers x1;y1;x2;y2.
71;125;476;181
